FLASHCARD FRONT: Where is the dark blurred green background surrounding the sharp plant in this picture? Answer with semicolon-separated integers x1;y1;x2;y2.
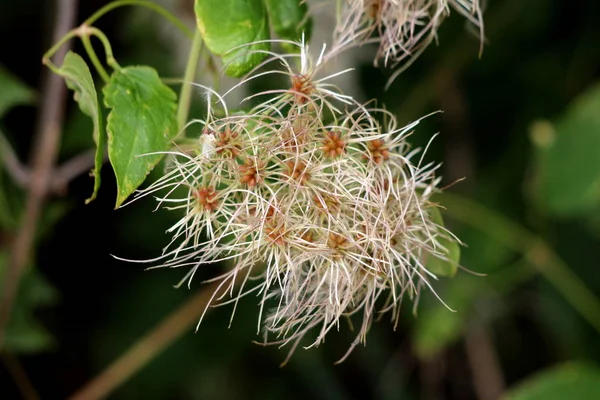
0;0;600;400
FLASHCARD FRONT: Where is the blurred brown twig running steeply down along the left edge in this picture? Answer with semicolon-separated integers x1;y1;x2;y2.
0;0;77;352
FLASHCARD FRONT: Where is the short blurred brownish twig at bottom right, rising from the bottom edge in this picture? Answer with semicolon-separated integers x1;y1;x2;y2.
465;325;504;400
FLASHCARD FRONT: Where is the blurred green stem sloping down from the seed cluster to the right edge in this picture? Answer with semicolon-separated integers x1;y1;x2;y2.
442;193;600;333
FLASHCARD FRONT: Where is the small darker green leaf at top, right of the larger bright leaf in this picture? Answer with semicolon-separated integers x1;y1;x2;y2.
264;0;312;51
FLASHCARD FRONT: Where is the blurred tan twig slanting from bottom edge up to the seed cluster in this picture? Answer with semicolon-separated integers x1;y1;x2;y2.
71;283;219;400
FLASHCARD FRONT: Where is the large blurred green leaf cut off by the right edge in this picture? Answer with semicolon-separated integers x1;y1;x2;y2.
531;85;600;216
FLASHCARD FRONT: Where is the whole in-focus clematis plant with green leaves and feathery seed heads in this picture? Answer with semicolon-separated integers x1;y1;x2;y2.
45;0;482;361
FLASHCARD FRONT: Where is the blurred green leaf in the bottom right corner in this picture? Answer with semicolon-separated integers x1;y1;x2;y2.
502;363;600;400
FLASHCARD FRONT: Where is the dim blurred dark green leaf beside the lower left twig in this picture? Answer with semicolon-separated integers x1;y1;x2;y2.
0;253;58;353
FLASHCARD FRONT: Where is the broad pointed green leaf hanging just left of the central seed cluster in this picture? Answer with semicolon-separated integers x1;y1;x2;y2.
104;66;177;207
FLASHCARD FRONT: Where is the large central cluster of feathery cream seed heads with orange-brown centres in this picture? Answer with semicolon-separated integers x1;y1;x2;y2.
132;43;454;362
